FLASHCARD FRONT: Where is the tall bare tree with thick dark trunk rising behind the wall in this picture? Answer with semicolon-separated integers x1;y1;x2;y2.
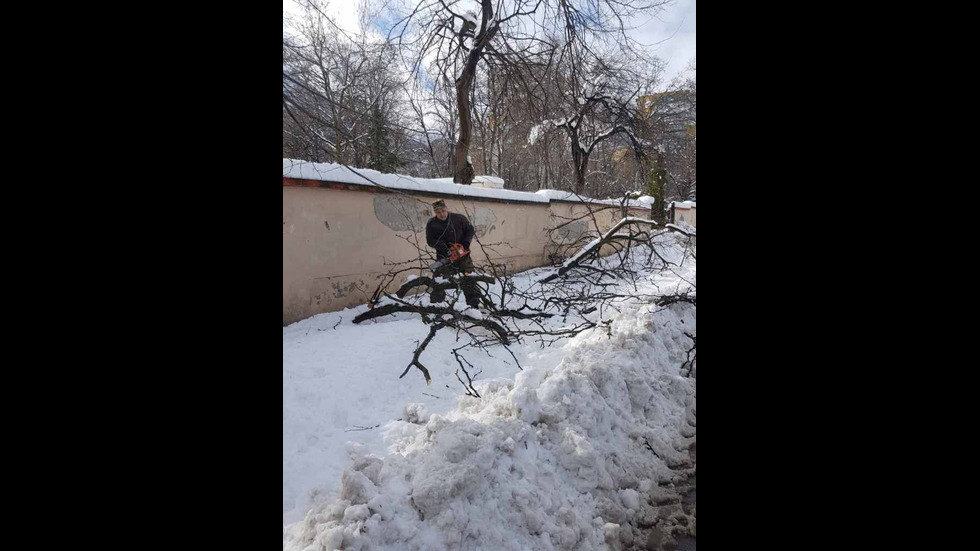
390;0;666;184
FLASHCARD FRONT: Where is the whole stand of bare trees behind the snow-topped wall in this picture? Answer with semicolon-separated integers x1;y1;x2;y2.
283;0;697;207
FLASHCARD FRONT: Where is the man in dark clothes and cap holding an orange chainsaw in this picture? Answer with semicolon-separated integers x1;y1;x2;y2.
425;200;481;308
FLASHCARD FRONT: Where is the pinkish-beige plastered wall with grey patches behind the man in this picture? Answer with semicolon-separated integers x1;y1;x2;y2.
282;178;649;326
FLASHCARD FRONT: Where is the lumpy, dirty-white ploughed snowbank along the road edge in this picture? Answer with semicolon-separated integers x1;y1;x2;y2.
284;292;697;551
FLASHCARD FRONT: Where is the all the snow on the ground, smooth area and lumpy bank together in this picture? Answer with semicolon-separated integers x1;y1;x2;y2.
283;235;697;551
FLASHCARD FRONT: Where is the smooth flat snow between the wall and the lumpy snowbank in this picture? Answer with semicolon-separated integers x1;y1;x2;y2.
282;271;548;526
